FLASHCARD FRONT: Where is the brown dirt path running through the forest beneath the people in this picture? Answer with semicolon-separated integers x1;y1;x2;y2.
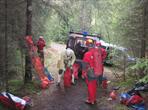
31;43;126;110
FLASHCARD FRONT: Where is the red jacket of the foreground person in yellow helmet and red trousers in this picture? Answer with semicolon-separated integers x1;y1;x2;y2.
83;48;103;76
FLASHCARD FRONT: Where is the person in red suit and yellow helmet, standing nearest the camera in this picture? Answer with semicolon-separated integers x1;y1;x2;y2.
82;39;102;104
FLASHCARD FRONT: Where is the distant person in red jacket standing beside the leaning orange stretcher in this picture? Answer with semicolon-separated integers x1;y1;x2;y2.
37;36;46;65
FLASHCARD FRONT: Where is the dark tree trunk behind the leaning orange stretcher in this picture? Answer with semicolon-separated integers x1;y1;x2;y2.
25;0;32;83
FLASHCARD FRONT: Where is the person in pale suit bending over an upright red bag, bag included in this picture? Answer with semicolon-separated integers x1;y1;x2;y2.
57;48;76;87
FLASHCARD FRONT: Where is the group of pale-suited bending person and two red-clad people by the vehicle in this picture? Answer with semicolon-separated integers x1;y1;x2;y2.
57;39;107;104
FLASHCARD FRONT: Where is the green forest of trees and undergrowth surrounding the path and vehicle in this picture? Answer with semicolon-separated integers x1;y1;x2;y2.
0;0;148;110
